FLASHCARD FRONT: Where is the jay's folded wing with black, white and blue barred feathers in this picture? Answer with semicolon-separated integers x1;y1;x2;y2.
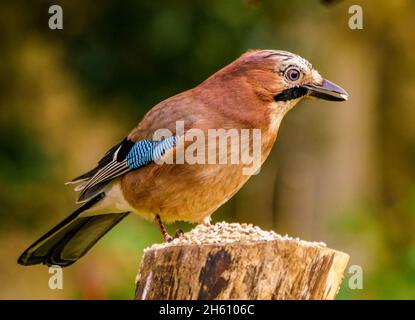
68;136;177;202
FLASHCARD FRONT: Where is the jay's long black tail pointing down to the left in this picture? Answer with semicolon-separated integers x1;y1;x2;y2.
17;192;128;267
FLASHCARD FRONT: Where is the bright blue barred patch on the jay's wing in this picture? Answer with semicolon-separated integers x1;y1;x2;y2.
127;136;177;169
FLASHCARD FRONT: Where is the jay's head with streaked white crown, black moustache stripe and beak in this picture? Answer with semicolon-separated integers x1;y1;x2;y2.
226;50;348;113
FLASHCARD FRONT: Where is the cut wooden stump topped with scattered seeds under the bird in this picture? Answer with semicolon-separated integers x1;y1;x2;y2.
135;222;349;300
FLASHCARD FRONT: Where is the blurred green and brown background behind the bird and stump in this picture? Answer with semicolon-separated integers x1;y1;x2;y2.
0;0;415;299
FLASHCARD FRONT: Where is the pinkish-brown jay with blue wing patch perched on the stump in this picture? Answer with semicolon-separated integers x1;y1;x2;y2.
18;50;348;267
